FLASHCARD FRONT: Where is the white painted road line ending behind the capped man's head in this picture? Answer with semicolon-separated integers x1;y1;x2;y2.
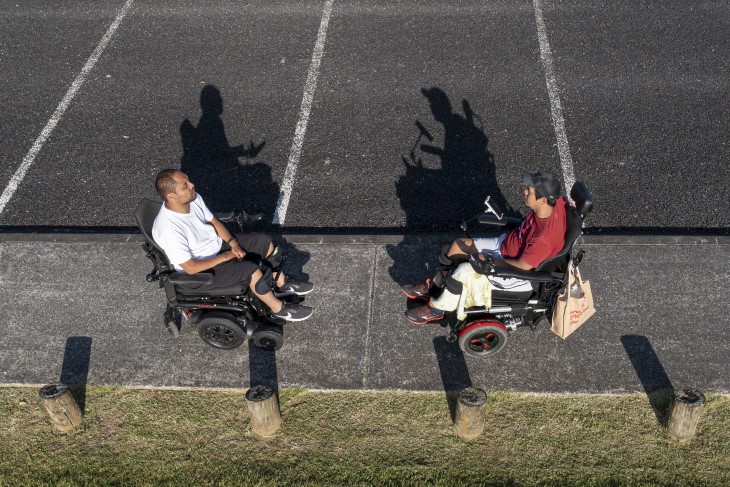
532;0;575;195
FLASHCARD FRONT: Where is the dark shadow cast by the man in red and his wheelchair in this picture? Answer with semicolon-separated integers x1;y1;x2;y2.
386;87;519;285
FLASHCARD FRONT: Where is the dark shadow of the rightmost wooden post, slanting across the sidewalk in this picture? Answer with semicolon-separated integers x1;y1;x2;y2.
621;335;674;426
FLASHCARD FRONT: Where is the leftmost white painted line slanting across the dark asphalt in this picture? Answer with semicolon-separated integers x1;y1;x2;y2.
0;0;134;215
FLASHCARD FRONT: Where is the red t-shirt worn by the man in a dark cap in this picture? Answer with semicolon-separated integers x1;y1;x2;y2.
499;196;569;269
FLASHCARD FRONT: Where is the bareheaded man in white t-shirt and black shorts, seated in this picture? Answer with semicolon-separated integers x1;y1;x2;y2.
152;169;313;321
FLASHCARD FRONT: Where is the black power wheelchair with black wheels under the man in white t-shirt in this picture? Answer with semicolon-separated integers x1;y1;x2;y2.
134;198;304;351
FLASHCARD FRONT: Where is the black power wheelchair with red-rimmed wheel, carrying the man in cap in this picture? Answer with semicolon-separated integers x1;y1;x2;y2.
441;181;593;357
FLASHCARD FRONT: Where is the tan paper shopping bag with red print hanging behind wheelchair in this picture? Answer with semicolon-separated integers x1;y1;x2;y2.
550;261;596;338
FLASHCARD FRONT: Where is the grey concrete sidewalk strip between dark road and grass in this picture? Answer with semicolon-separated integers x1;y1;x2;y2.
0;234;730;393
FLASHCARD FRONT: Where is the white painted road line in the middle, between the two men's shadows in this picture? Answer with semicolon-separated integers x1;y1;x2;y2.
272;0;334;225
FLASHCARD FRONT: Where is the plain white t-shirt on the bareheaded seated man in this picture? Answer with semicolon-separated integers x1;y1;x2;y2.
152;193;223;272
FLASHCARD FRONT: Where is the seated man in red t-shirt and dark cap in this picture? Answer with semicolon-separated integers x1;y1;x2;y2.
403;172;569;324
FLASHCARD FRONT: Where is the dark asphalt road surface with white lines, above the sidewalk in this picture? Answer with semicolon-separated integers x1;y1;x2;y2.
0;0;730;235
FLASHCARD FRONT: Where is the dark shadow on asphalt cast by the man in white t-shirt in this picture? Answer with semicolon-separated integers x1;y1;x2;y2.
180;85;279;233
